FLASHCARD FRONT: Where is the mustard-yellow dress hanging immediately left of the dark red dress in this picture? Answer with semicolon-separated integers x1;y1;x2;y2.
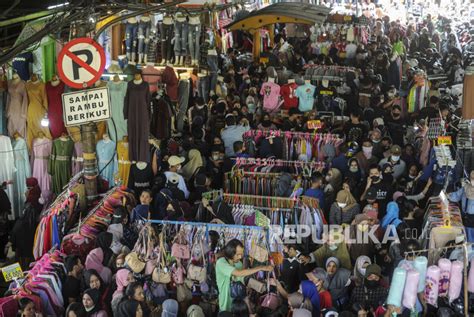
26;81;51;149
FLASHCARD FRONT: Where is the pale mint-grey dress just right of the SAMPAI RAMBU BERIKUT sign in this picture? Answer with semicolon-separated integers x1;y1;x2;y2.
107;81;128;142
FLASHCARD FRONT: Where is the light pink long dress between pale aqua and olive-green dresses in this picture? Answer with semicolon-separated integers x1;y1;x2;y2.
31;138;52;203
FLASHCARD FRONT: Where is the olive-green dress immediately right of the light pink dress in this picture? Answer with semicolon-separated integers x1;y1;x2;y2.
48;138;74;195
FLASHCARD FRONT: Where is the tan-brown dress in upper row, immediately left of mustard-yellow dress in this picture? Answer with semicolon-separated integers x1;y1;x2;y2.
6;80;28;138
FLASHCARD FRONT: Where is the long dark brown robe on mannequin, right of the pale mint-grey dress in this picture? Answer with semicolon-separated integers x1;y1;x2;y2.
123;72;151;162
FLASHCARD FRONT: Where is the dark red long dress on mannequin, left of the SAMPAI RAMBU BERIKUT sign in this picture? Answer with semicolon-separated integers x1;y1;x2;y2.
46;75;66;139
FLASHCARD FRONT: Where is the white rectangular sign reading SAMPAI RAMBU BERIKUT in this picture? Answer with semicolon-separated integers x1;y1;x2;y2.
62;87;110;127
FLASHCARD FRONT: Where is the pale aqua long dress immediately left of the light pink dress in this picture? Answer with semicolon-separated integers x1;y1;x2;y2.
12;138;31;219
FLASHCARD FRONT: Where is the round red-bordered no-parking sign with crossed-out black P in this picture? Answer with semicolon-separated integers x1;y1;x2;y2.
57;38;105;89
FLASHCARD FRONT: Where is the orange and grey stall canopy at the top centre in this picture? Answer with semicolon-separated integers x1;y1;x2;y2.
226;2;331;31
